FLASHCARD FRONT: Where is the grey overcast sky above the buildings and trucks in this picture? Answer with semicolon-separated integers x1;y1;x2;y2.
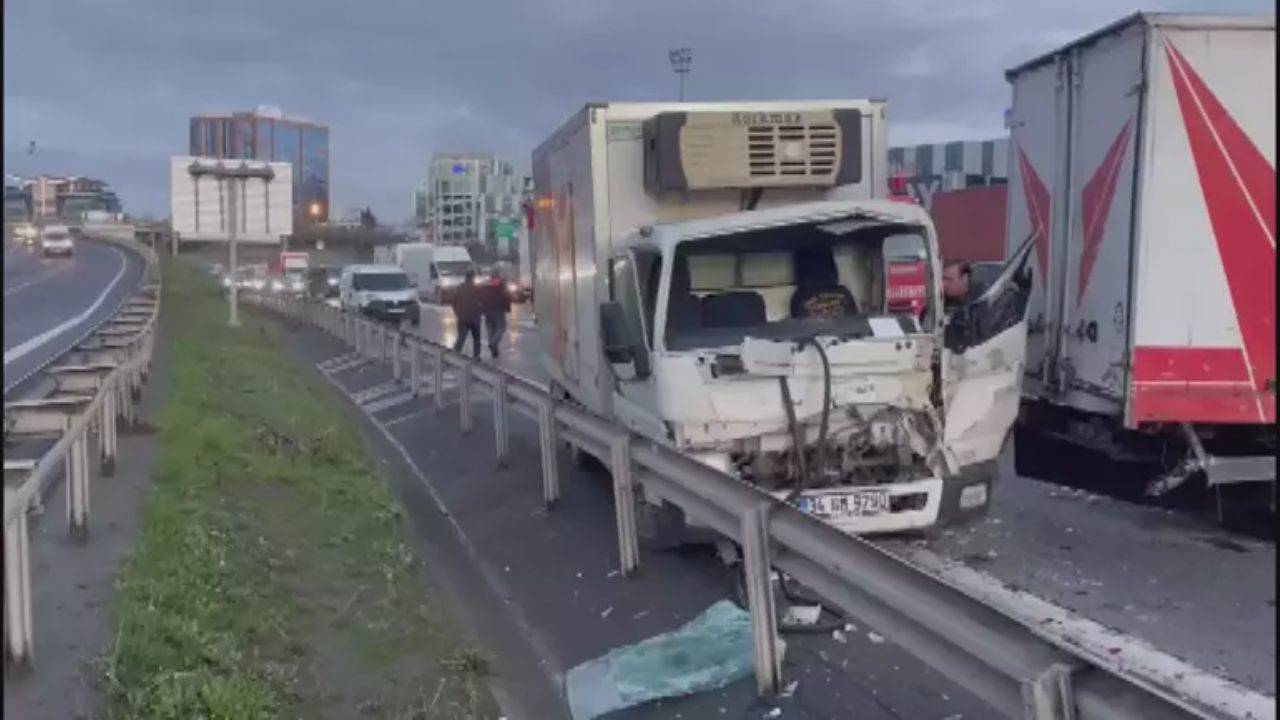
4;0;1272;223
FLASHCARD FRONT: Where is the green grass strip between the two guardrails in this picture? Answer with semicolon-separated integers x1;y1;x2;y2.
101;261;497;719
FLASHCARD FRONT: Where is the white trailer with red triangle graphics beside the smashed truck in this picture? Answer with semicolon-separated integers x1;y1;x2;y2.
1006;14;1276;511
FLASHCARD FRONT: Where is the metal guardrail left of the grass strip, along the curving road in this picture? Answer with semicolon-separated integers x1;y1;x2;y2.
4;238;160;664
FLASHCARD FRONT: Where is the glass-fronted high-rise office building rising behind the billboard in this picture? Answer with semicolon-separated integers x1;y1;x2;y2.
189;105;329;227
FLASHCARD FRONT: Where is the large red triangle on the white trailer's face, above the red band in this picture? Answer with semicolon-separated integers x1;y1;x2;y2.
1165;40;1276;421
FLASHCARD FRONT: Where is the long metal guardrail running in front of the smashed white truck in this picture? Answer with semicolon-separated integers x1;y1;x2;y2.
247;293;1275;720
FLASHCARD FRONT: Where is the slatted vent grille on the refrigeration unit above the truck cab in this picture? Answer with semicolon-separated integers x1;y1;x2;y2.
746;123;840;179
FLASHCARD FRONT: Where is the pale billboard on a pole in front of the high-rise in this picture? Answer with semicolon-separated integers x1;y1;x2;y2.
169;155;293;243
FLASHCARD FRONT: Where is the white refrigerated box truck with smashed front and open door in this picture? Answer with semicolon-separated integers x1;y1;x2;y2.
531;101;1030;543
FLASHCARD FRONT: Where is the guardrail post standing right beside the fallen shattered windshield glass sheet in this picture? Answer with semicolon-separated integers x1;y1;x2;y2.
742;502;782;696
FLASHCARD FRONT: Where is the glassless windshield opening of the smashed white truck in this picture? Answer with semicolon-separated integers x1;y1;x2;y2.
666;223;928;350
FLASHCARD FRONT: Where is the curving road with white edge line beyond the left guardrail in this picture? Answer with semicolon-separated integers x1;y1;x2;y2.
4;233;142;398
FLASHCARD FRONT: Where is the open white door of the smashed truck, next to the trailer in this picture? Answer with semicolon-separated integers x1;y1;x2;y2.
942;233;1036;470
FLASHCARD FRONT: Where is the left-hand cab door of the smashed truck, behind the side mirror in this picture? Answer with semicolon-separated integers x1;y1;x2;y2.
609;249;666;438
